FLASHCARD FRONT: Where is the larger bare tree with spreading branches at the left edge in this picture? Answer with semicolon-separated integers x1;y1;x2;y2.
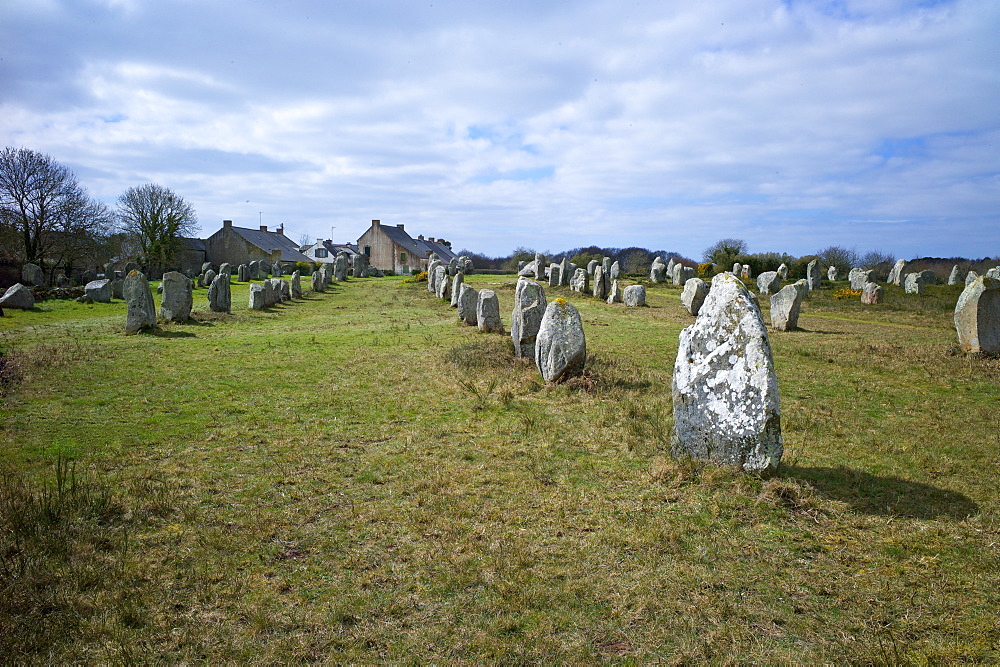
0;147;100;265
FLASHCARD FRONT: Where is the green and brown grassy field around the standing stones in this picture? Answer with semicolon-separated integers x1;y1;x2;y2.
0;276;1000;663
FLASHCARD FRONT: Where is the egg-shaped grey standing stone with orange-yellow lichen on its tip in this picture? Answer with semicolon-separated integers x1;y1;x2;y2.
535;298;587;382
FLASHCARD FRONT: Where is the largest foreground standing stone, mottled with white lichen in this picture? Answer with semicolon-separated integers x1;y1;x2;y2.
671;273;783;472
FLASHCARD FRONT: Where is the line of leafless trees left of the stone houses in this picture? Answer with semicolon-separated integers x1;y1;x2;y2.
0;147;198;280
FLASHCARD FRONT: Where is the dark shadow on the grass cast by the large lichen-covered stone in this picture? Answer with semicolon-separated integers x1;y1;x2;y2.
780;465;979;520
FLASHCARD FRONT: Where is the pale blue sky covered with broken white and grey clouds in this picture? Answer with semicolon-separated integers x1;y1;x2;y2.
0;0;1000;259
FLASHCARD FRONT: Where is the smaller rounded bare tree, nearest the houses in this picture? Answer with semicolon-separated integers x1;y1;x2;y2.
118;183;198;274
